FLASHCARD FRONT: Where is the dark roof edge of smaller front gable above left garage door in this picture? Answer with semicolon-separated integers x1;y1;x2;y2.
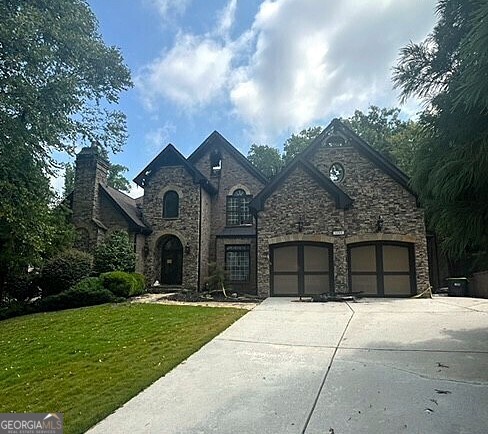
249;158;353;211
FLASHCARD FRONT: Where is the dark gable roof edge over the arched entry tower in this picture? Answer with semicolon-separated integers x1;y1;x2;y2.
134;143;216;194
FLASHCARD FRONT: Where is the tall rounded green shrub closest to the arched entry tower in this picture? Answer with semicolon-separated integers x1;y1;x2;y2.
94;231;136;273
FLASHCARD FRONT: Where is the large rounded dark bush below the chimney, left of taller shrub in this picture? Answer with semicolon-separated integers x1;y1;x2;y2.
40;249;93;296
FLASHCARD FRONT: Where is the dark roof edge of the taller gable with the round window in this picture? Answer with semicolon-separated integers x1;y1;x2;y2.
304;119;416;196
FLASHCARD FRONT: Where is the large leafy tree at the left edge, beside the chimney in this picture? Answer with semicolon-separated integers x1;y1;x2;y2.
0;0;131;294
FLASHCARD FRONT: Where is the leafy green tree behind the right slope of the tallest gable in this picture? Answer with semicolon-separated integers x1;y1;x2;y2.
342;105;421;175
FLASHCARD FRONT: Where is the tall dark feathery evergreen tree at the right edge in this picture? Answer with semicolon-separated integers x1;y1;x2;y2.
394;0;488;258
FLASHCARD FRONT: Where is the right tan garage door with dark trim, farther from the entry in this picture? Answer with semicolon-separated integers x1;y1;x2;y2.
348;242;416;297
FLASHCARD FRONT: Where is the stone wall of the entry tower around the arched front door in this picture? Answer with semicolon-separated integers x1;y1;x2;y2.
143;166;200;288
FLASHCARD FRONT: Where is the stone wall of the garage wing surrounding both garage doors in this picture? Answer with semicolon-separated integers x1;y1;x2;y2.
258;147;429;296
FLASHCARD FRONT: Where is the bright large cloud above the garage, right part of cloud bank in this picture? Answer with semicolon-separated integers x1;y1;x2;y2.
230;0;434;135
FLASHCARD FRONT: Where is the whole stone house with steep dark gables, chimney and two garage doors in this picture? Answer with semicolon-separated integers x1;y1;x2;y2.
71;119;429;297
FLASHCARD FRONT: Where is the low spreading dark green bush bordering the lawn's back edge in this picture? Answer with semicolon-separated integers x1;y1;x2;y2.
39;277;120;311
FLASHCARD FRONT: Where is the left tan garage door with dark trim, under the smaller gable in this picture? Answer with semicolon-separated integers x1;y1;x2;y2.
270;243;333;296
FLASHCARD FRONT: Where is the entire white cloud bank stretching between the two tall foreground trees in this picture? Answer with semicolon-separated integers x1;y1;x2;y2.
136;0;436;137
